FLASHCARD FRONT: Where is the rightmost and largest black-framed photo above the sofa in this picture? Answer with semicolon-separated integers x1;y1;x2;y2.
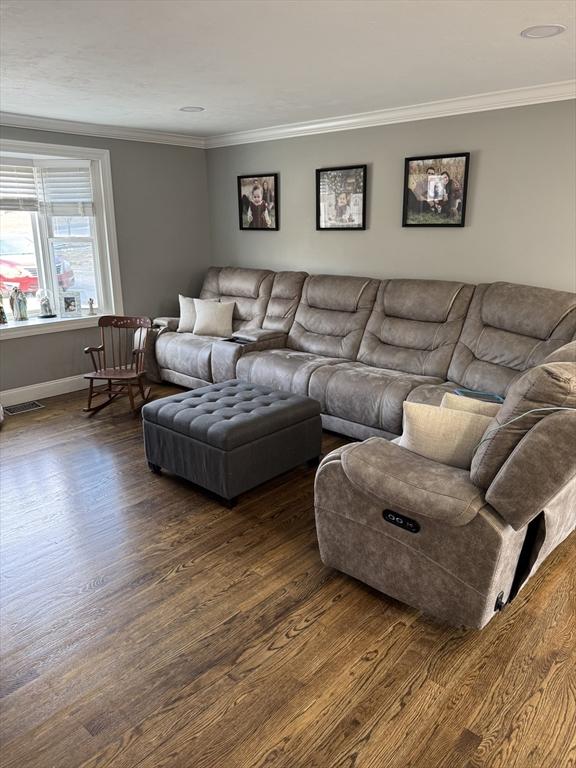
402;152;470;227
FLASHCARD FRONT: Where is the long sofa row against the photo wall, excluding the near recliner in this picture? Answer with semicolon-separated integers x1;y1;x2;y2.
148;267;576;439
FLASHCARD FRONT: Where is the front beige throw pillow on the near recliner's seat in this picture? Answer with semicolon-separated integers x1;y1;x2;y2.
400;402;492;469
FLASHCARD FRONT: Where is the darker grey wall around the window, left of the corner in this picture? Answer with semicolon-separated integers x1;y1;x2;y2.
0;127;210;390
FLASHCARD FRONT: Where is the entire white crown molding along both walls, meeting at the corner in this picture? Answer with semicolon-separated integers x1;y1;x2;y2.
0;80;576;149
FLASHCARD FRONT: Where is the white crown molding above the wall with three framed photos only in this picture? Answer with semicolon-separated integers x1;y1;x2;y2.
205;80;576;149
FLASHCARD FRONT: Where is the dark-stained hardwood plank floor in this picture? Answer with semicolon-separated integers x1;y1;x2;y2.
0;388;576;768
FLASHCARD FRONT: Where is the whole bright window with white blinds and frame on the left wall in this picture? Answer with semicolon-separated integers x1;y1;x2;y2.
0;142;121;335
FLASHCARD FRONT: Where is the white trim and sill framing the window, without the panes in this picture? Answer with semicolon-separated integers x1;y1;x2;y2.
0;139;124;341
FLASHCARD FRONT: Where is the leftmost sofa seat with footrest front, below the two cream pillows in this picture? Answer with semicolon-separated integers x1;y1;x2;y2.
156;331;217;381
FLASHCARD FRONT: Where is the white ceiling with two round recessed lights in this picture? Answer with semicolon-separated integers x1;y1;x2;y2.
0;0;576;142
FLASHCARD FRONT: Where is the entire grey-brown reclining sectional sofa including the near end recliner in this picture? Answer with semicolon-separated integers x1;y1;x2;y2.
148;268;576;627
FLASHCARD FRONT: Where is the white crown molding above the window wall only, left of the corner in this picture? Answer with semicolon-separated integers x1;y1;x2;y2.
0;112;206;149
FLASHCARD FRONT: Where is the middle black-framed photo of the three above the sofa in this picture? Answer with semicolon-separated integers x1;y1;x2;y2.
316;165;366;230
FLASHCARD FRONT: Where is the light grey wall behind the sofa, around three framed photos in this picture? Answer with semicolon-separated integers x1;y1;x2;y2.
208;102;576;290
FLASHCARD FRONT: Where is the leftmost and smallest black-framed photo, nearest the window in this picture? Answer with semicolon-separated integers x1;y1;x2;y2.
238;173;280;231
